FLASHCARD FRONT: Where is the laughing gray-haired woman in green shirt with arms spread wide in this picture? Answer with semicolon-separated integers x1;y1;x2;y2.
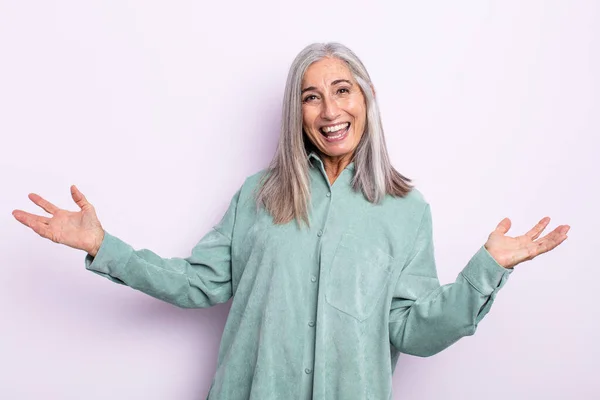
13;43;569;400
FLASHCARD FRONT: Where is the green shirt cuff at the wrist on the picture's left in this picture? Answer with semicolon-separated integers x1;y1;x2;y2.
85;230;134;283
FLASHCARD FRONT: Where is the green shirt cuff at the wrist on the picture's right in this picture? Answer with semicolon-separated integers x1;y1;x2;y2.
461;245;514;296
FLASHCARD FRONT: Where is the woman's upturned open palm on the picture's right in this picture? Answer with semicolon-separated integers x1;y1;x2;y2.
485;217;570;268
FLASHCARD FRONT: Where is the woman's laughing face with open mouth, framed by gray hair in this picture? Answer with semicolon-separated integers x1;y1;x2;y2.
302;58;367;162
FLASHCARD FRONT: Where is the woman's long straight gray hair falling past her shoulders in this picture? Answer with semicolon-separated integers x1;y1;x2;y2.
256;42;413;226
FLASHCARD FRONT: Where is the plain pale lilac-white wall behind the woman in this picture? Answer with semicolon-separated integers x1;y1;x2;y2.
0;0;600;400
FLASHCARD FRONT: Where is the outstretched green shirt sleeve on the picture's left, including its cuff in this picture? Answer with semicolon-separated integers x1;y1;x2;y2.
85;190;240;308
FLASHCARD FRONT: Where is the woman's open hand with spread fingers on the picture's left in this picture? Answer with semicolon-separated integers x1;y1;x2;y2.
12;185;104;257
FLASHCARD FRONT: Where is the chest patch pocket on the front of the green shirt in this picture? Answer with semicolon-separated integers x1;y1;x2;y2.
325;233;394;322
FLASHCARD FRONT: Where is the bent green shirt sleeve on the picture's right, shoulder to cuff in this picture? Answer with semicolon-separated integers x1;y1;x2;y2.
389;204;513;357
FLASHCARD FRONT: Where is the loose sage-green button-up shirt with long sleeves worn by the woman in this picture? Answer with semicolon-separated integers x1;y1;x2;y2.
85;153;513;400
